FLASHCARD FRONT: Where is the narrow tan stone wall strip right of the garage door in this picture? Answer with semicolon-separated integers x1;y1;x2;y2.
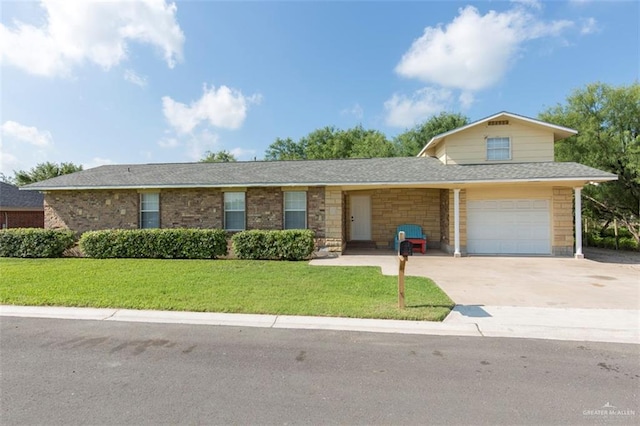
551;187;574;256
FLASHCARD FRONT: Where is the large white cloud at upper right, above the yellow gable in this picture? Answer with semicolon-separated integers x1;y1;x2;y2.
396;2;574;91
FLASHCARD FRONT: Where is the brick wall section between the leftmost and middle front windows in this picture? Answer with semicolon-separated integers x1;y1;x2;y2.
160;188;223;229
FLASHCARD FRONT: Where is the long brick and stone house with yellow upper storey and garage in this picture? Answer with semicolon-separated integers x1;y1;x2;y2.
24;112;616;257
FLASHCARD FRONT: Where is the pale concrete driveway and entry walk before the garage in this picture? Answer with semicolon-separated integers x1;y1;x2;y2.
312;249;640;310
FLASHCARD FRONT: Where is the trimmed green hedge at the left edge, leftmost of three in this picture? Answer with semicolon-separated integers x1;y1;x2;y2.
0;228;76;257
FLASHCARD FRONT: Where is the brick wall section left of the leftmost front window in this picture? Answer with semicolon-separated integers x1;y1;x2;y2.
44;190;140;232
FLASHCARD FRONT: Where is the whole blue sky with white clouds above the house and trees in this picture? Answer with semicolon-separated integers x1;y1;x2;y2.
0;0;640;176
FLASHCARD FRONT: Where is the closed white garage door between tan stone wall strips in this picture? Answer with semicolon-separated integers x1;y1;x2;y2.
467;200;551;254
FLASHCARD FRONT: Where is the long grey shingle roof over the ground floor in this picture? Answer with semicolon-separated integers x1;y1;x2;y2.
25;157;616;190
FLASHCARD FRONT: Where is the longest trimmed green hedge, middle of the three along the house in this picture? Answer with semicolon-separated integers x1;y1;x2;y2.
80;229;227;259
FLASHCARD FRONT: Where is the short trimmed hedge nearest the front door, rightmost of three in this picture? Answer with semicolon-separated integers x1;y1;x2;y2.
231;229;315;260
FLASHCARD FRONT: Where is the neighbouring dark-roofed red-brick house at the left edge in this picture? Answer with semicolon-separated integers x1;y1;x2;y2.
0;182;44;229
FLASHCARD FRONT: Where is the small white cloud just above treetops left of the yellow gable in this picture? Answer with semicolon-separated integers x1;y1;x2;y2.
384;87;453;127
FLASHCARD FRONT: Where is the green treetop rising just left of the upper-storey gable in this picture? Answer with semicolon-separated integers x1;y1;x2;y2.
393;112;469;157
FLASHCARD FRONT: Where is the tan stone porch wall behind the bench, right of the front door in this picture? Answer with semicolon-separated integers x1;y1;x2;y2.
347;188;440;248
